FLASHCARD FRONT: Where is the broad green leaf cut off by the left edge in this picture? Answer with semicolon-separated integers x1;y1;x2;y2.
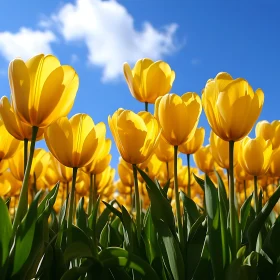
0;197;12;267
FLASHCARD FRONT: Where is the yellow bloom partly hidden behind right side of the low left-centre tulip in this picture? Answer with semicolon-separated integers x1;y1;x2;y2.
83;123;112;174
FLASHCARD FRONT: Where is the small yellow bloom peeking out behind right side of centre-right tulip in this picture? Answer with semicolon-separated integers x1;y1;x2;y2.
179;127;205;155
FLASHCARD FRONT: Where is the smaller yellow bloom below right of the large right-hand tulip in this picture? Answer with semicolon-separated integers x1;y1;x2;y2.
238;136;272;176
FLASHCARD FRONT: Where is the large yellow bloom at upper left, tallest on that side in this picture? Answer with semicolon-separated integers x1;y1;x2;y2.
9;54;79;127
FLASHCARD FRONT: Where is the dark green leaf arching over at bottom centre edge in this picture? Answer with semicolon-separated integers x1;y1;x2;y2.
99;247;159;280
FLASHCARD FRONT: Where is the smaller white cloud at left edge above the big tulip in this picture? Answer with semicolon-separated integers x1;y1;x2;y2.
0;27;56;61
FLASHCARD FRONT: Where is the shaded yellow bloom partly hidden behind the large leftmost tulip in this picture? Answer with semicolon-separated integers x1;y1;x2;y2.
0;96;44;141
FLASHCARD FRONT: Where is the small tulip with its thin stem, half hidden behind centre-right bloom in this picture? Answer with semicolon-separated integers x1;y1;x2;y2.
178;127;205;197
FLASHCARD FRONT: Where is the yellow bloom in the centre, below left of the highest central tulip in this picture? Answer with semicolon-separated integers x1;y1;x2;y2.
108;109;161;164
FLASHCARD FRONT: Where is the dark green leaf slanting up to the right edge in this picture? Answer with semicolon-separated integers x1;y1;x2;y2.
248;187;280;252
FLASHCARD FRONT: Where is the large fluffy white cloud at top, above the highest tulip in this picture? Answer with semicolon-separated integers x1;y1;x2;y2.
50;0;177;81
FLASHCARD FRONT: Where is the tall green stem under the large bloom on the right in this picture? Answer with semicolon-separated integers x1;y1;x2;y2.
229;141;235;255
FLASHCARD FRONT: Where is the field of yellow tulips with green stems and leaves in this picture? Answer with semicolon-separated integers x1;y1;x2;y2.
0;54;280;280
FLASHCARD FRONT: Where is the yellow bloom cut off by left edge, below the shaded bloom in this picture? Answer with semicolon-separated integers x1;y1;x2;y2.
0;119;20;161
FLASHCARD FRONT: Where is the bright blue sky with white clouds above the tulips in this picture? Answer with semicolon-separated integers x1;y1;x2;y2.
0;0;280;172
